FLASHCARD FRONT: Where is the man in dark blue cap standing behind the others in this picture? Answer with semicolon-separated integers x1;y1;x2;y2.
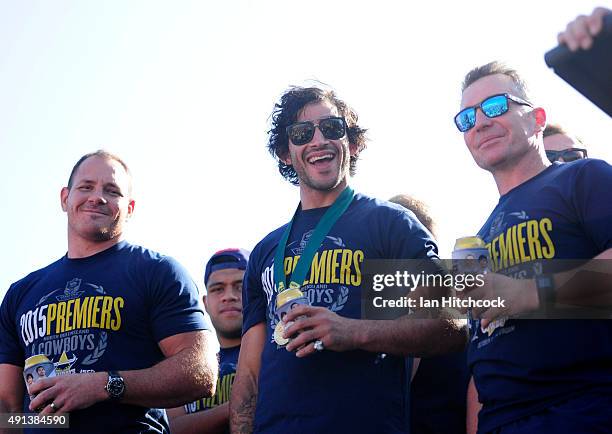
168;249;249;434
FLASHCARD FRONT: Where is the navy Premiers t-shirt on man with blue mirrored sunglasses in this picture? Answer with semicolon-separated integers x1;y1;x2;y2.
468;159;612;431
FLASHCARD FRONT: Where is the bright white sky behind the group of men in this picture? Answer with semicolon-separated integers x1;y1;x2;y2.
0;0;612;306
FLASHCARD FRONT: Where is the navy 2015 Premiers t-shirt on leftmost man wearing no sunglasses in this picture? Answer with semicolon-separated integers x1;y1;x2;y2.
0;241;210;434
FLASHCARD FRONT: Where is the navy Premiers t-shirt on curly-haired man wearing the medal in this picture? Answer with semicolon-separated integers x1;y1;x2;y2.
243;194;437;433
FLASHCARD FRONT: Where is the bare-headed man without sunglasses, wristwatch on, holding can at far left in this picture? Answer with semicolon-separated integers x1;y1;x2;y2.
0;151;217;433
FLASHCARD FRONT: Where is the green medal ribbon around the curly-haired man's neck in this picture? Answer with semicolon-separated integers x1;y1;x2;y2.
274;187;355;292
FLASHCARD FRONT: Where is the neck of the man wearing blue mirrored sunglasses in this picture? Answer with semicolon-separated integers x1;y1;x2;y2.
491;146;550;196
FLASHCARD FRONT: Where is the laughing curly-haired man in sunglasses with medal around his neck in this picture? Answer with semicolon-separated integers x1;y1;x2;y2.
230;87;466;433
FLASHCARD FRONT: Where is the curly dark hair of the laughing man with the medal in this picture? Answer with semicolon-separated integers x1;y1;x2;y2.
268;86;367;185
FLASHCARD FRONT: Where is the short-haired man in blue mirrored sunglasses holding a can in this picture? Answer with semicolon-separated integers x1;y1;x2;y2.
454;62;612;433
